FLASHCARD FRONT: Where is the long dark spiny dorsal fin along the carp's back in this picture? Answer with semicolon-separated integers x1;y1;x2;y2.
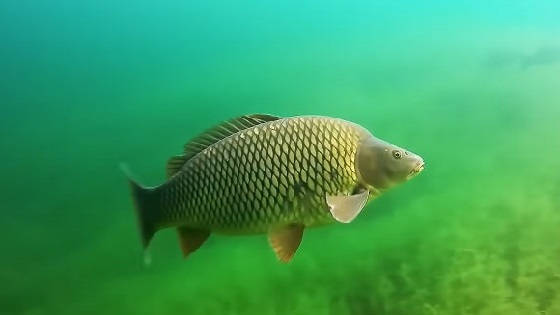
167;114;281;178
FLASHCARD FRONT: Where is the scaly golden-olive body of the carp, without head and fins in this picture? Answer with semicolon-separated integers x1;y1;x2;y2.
157;117;364;234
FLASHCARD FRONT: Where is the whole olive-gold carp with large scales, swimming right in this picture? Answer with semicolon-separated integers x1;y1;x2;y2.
128;114;425;263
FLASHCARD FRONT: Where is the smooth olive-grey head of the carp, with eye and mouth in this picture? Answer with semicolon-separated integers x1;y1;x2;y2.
356;135;425;190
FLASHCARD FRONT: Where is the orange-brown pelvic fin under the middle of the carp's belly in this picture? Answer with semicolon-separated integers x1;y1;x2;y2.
268;224;304;263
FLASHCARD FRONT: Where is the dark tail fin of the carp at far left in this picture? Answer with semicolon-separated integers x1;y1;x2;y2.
121;165;159;249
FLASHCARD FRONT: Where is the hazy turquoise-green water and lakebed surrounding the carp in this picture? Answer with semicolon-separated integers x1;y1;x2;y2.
0;0;560;315
